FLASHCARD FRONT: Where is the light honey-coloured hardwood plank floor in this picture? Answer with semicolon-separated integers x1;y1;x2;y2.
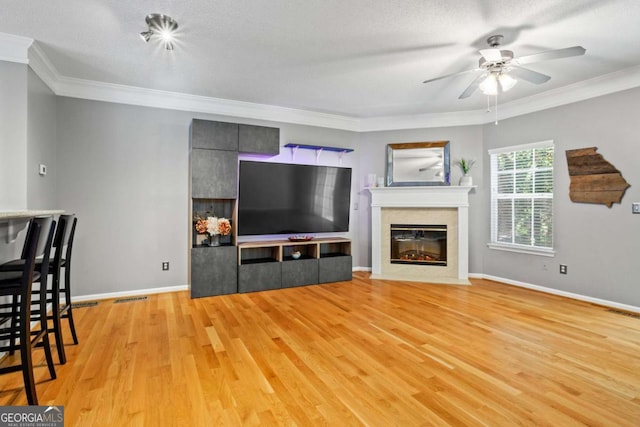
0;273;640;426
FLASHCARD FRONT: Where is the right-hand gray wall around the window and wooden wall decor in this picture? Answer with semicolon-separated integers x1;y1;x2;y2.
478;89;640;307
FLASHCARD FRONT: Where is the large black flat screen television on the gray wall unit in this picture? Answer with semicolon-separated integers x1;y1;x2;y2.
238;160;351;236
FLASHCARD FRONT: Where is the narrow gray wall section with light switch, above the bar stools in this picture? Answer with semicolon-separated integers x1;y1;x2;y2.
26;68;58;209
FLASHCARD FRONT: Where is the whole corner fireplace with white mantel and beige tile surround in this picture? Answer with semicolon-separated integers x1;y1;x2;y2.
369;186;473;285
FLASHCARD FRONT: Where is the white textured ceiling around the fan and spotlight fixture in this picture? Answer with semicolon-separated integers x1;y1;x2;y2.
0;0;640;118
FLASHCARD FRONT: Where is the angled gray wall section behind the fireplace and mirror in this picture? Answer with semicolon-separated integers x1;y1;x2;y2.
356;126;486;273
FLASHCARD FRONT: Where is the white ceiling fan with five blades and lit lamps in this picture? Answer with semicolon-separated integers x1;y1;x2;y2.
423;34;586;99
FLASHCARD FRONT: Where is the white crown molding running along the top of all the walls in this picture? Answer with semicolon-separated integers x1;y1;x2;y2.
15;33;640;132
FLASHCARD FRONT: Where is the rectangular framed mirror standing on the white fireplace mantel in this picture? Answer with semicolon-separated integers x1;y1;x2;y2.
386;141;449;187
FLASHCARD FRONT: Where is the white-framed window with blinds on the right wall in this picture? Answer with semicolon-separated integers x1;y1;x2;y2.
489;141;553;256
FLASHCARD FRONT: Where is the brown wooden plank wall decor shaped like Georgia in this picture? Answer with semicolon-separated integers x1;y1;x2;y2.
566;147;631;208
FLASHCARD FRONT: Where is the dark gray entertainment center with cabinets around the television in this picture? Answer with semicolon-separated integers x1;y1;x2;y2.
189;119;352;298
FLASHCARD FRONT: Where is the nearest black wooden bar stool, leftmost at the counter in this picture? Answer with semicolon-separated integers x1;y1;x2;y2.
0;217;56;405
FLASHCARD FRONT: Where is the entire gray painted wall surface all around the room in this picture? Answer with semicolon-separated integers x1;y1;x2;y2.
5;61;640;306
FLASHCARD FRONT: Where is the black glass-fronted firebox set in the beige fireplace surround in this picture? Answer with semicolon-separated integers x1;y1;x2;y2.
391;224;447;266
